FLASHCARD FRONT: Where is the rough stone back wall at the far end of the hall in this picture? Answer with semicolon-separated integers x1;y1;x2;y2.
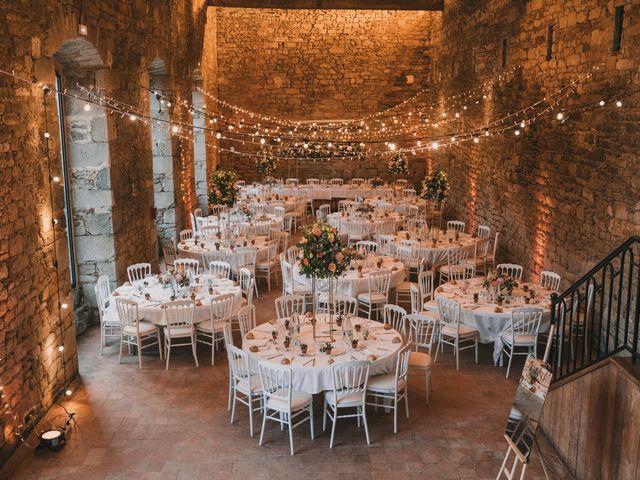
210;8;441;184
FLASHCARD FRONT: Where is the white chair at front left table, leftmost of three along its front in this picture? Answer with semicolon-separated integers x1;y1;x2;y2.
116;298;162;370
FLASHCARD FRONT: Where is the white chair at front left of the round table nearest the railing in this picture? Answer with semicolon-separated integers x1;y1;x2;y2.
434;297;480;370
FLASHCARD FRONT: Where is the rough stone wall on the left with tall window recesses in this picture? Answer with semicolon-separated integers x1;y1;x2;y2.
0;0;206;461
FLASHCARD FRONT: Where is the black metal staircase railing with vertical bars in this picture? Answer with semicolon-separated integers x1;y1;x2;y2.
549;236;640;382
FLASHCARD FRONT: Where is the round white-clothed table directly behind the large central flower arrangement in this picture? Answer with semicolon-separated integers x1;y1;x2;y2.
293;255;405;297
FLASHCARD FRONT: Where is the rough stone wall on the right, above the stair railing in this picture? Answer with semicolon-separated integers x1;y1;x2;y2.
429;0;640;286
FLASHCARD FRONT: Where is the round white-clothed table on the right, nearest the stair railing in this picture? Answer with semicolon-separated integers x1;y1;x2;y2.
435;277;552;363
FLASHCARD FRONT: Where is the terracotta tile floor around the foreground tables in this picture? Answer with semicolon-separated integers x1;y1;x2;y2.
0;287;544;480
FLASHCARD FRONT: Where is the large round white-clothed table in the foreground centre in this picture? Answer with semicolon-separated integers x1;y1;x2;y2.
242;314;402;394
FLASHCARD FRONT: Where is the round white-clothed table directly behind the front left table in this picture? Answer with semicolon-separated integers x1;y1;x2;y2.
178;236;269;269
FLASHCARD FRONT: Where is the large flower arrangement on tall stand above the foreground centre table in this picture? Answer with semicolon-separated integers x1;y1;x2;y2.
298;222;355;278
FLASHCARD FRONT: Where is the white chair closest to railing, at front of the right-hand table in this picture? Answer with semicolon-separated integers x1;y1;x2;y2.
500;307;544;378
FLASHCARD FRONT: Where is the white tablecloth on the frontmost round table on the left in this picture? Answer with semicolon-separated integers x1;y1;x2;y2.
108;275;243;325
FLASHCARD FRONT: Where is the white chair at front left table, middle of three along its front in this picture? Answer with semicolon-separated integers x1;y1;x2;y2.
162;300;199;370
